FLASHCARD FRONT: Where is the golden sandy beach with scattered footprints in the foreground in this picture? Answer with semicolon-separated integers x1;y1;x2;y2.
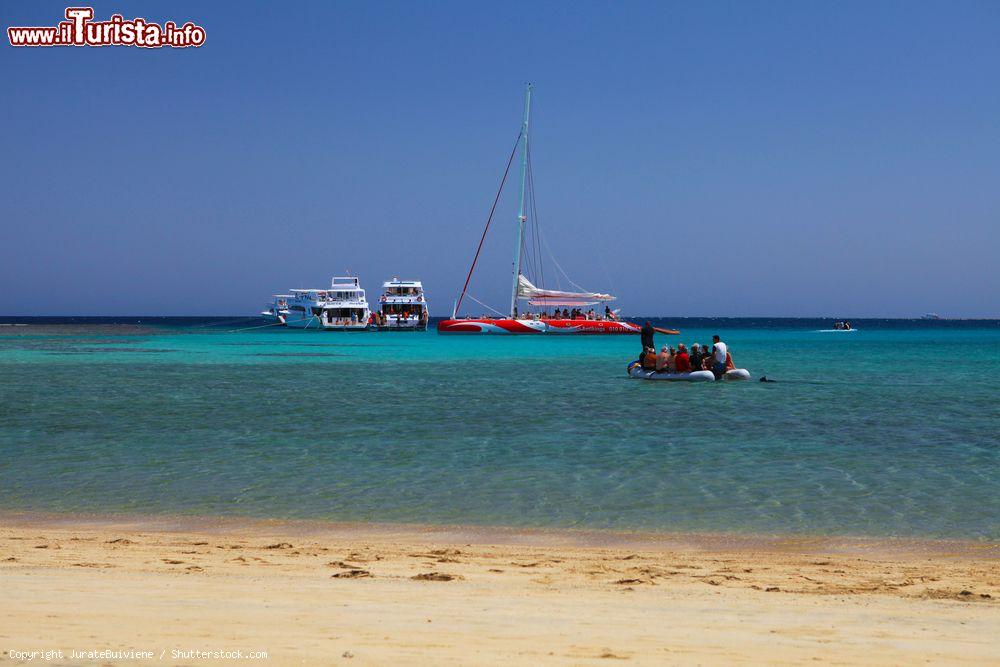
0;514;1000;665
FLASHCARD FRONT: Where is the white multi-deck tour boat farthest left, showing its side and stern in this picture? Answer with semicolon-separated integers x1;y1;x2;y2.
285;276;371;331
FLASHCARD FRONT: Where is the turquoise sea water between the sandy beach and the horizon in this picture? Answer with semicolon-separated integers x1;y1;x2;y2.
0;318;1000;540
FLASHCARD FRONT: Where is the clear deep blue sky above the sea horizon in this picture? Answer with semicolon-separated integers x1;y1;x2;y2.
0;2;1000;317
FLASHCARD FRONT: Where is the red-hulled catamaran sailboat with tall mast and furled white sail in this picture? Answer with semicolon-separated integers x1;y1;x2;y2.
438;84;639;334
